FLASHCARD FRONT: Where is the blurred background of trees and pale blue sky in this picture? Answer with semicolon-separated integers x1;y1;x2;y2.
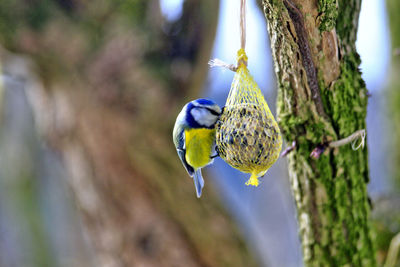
0;0;400;267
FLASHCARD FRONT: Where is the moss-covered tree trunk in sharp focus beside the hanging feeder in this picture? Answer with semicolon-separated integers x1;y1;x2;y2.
263;0;376;266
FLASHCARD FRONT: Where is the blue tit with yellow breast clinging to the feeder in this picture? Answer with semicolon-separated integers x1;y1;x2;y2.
173;99;221;197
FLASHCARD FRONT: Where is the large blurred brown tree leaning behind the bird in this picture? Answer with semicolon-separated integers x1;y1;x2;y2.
0;0;255;267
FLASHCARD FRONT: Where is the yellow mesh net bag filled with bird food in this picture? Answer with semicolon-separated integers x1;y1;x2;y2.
216;49;282;186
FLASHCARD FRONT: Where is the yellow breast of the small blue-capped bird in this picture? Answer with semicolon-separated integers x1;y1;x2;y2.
185;128;215;169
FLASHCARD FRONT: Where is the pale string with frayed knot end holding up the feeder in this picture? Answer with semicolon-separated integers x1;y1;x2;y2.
208;0;247;72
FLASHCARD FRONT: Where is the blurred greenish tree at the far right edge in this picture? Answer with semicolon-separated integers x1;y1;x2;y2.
374;0;400;267
